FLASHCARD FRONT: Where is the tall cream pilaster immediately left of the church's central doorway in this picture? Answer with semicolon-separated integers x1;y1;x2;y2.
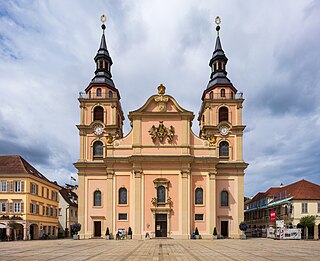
132;170;143;239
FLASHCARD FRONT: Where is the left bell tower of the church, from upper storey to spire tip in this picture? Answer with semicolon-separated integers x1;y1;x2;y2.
77;15;124;162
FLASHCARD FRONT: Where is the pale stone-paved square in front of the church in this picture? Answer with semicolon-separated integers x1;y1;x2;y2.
0;238;320;261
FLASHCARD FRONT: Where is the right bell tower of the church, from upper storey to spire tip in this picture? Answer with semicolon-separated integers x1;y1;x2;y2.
198;16;245;162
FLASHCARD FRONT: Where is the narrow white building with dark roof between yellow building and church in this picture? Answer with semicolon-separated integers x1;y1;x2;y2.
59;185;78;237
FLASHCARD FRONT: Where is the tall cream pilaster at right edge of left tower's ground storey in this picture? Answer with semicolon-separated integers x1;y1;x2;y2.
105;169;115;233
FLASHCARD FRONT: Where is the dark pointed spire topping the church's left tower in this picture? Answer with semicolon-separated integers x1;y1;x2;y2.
91;15;114;87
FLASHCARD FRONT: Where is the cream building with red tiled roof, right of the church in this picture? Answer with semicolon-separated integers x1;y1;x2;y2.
244;179;320;239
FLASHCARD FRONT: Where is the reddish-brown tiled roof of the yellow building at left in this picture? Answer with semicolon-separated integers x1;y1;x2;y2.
0;156;52;183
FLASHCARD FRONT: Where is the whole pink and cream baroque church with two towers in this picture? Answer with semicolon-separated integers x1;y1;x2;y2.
74;17;248;239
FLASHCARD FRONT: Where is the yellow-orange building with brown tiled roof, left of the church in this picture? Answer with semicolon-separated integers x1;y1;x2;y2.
0;156;60;240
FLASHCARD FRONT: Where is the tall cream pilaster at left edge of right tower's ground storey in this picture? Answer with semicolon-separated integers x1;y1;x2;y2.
207;169;217;235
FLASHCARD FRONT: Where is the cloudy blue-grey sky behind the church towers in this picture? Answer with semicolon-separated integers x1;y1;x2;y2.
0;0;320;196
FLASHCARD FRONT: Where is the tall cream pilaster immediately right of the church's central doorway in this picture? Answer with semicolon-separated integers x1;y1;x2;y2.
180;170;191;239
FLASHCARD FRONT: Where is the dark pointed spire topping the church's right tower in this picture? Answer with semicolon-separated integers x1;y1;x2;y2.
208;16;230;88
